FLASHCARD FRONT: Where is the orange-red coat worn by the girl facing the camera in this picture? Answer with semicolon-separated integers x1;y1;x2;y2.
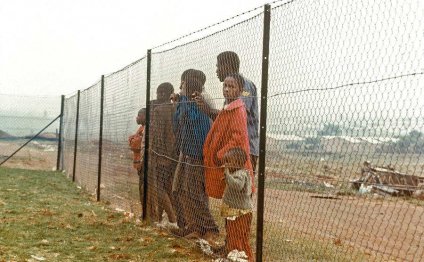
203;99;254;198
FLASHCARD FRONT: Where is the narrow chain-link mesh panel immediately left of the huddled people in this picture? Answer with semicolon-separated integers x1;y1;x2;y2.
100;58;146;214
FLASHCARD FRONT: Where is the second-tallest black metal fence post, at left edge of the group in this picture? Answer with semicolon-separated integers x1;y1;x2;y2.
142;49;152;221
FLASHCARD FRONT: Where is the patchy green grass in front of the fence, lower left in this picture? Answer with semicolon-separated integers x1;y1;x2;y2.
0;168;210;261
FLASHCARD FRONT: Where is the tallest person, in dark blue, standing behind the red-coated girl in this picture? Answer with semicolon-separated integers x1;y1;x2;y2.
195;51;259;170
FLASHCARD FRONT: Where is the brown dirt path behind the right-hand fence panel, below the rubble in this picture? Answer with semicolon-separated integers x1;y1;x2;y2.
265;189;424;261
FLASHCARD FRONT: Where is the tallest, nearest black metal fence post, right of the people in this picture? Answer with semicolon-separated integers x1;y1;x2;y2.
256;4;271;262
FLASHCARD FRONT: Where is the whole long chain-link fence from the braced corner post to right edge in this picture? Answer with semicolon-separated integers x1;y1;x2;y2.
55;0;424;261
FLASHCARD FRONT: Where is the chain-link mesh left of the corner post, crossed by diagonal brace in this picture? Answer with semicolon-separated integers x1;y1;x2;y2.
0;94;60;170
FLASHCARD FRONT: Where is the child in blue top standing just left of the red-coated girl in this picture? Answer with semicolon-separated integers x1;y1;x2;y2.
171;69;219;240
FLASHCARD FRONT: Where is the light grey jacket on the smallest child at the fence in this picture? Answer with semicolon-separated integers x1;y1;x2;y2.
222;169;252;210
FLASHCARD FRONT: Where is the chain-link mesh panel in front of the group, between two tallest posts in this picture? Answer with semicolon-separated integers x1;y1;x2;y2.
149;10;263;257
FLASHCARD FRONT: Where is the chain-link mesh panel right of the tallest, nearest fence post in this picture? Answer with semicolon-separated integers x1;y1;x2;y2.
264;1;424;261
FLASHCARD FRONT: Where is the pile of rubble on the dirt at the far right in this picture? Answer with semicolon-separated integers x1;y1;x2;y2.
350;161;424;198
